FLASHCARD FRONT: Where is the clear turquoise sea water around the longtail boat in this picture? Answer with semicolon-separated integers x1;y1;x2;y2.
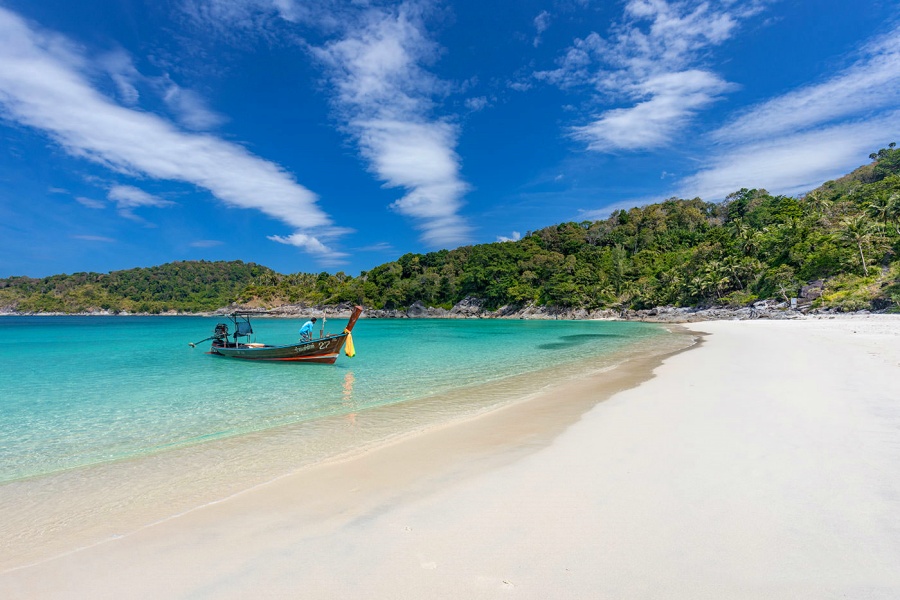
0;317;667;482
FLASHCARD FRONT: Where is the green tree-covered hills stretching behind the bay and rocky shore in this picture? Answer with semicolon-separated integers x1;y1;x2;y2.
0;144;900;313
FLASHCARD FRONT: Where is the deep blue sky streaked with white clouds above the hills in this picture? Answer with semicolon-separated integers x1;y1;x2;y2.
0;0;900;277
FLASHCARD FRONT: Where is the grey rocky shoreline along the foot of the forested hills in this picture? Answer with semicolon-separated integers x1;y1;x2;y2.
0;297;887;323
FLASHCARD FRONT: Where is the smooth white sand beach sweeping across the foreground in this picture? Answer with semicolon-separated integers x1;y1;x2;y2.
0;316;900;600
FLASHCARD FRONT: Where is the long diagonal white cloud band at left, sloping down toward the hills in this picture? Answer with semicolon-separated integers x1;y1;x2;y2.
0;8;338;252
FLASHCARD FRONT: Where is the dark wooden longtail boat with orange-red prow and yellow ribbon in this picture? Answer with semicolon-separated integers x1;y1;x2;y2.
200;306;363;364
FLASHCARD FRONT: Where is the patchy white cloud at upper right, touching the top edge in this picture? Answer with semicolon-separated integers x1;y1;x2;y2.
535;0;764;151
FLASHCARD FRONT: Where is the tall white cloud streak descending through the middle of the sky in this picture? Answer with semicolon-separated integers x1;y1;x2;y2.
313;3;470;246
